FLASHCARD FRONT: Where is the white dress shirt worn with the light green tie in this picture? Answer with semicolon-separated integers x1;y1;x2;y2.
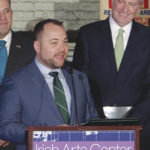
109;16;132;50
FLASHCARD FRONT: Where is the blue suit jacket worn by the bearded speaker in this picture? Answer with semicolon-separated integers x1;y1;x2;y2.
0;62;97;150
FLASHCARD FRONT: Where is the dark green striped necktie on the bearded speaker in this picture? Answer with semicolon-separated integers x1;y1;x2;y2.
50;72;69;124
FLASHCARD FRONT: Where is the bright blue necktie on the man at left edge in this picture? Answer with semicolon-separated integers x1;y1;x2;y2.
0;40;8;84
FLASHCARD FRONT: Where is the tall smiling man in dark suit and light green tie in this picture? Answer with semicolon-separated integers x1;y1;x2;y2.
73;0;150;150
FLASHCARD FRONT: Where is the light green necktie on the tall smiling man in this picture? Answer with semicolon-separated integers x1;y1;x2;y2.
115;29;124;70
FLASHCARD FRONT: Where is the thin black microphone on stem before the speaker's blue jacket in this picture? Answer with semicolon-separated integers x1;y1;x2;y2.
67;67;79;126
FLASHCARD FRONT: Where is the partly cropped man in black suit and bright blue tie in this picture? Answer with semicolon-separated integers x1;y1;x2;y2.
0;0;35;150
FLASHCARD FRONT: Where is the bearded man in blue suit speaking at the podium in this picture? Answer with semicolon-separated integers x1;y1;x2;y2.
0;19;98;150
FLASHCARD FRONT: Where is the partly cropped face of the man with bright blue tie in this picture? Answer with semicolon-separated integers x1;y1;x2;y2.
0;0;12;39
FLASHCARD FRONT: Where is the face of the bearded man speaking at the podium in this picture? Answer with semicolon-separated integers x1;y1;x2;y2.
34;23;68;69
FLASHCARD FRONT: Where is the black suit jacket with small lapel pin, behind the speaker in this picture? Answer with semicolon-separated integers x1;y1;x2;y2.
6;31;35;75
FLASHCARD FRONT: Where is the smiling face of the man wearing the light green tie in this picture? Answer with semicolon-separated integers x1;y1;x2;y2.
112;0;140;27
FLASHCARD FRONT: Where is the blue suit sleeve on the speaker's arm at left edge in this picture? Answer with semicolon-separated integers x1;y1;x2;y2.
0;78;25;143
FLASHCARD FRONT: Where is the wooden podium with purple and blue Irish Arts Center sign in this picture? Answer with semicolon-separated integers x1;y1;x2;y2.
27;119;142;150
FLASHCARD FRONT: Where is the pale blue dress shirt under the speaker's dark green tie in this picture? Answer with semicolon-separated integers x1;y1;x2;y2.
35;58;71;114
